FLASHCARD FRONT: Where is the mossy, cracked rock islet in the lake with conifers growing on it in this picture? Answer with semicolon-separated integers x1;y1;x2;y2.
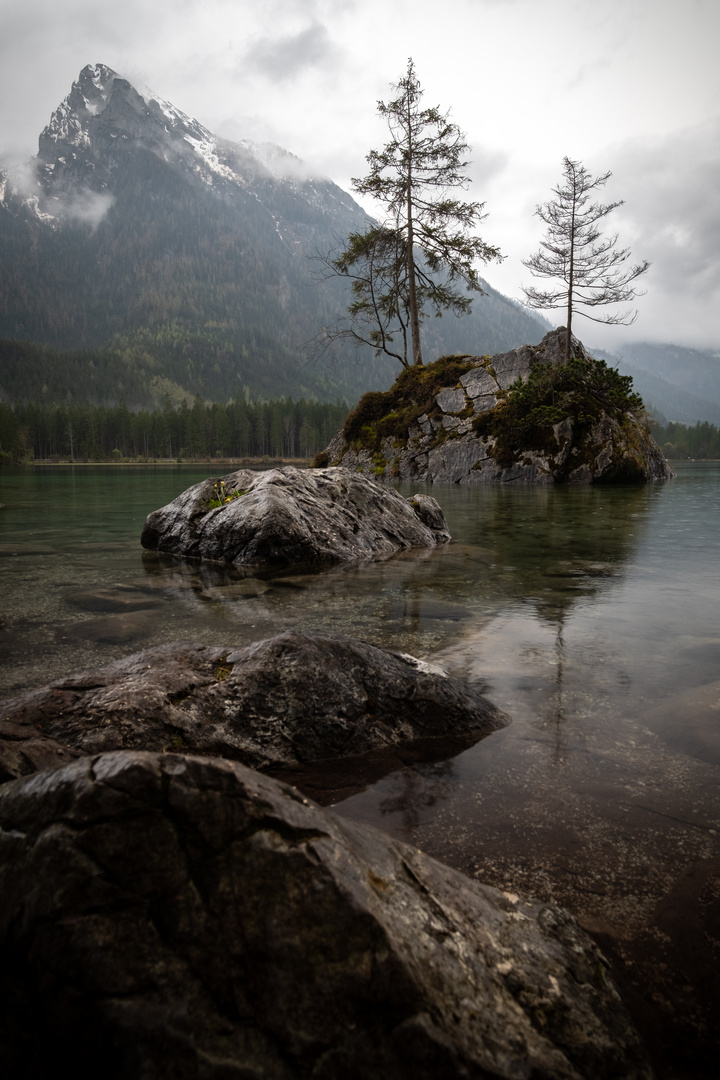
323;327;675;485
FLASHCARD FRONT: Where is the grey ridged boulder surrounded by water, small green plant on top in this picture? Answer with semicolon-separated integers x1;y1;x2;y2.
141;467;450;569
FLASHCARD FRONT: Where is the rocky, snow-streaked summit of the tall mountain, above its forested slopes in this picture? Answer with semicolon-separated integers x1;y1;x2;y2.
0;64;364;252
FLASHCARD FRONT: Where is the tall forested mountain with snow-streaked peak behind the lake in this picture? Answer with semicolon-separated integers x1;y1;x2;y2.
0;64;546;405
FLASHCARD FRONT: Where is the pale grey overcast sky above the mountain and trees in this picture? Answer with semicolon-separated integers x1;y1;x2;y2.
0;0;720;350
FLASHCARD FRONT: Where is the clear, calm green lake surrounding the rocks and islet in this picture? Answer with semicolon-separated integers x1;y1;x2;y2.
0;462;720;1078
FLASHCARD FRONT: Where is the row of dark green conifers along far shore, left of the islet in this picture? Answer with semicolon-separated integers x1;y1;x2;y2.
0;395;348;464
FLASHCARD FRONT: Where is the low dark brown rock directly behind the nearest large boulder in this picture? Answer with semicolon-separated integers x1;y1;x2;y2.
0;633;507;780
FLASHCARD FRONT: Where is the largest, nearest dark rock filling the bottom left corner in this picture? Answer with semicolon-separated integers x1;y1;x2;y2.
0;753;649;1080
